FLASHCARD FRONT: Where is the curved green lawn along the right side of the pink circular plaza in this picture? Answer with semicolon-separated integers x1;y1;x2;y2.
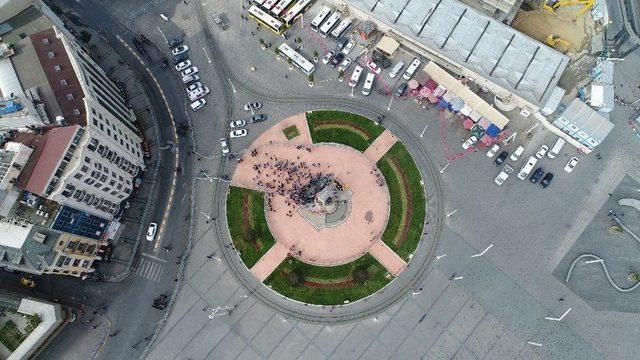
378;142;426;261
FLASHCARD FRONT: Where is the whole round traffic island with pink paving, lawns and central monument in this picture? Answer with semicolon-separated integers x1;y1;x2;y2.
226;110;432;320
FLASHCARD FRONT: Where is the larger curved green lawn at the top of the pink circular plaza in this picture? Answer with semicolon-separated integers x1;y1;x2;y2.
307;110;384;151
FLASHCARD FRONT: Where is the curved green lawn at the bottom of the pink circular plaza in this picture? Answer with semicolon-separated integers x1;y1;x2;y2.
264;254;393;305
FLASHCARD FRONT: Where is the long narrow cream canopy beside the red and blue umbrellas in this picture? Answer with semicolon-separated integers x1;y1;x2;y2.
424;61;509;129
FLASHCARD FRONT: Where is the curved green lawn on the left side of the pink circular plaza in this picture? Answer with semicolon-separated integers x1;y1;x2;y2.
227;186;275;269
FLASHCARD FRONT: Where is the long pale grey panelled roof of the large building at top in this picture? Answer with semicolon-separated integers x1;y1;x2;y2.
346;0;569;106
